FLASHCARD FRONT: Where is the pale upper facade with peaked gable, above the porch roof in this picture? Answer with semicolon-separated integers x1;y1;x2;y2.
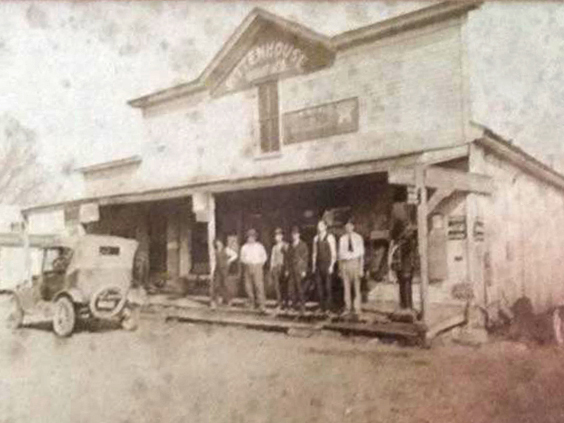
79;4;475;200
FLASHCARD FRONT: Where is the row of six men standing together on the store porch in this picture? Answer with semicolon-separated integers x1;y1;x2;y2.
211;220;365;314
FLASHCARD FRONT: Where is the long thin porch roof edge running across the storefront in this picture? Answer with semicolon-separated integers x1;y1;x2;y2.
22;144;469;215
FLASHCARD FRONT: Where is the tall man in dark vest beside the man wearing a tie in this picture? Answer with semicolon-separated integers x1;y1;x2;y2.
312;220;337;312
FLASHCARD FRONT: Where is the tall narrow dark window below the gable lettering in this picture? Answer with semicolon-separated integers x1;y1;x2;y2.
259;81;280;153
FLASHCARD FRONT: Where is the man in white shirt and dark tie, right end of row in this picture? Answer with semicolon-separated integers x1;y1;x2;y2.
339;219;364;315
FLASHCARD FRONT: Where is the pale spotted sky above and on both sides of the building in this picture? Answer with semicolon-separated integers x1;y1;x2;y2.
0;0;564;202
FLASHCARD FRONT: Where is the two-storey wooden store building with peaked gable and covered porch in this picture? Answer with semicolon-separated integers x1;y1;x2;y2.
25;2;564;330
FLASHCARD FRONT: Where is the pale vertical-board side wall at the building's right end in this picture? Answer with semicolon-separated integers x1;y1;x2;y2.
473;146;564;312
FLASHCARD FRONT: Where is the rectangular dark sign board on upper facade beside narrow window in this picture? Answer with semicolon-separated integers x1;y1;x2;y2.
282;97;358;144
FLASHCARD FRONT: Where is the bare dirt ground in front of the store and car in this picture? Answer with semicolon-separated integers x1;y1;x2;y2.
0;302;564;423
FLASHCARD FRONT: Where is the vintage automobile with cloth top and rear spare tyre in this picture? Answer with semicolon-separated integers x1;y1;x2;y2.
4;235;144;336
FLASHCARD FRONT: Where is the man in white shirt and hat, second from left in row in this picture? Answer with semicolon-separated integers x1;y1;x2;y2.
241;229;267;312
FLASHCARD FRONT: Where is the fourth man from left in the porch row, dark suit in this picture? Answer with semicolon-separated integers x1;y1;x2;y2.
286;226;309;313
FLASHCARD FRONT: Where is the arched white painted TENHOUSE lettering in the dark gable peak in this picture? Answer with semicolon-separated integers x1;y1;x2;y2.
226;41;308;90
